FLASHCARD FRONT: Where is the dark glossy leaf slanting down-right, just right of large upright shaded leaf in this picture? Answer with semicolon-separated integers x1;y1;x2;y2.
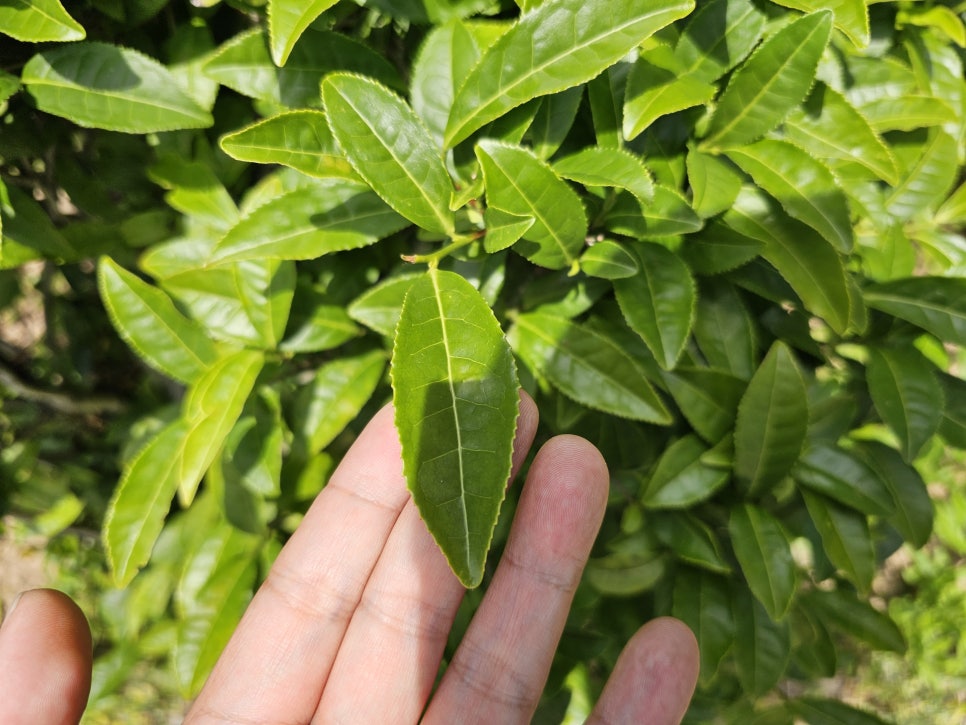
792;443;895;516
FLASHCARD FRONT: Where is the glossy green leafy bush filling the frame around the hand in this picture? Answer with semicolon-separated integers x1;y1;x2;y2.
0;0;966;723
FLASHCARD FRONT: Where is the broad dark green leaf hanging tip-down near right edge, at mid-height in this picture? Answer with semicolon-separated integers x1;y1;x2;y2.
865;347;943;462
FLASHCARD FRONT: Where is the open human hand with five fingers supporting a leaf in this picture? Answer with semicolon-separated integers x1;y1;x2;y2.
0;396;698;725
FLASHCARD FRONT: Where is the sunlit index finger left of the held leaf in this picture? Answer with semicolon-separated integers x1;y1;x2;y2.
188;406;409;723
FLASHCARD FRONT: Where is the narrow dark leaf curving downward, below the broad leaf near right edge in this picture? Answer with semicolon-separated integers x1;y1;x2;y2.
854;441;934;548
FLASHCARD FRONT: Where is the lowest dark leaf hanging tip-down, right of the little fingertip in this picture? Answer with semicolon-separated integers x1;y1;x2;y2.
734;587;792;697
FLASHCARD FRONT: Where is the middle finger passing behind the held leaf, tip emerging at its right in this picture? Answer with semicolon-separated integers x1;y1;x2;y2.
316;395;537;723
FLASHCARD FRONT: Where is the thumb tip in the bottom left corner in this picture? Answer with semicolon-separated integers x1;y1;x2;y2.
0;589;93;725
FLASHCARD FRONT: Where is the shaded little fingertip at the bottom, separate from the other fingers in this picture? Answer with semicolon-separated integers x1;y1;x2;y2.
587;617;699;725
